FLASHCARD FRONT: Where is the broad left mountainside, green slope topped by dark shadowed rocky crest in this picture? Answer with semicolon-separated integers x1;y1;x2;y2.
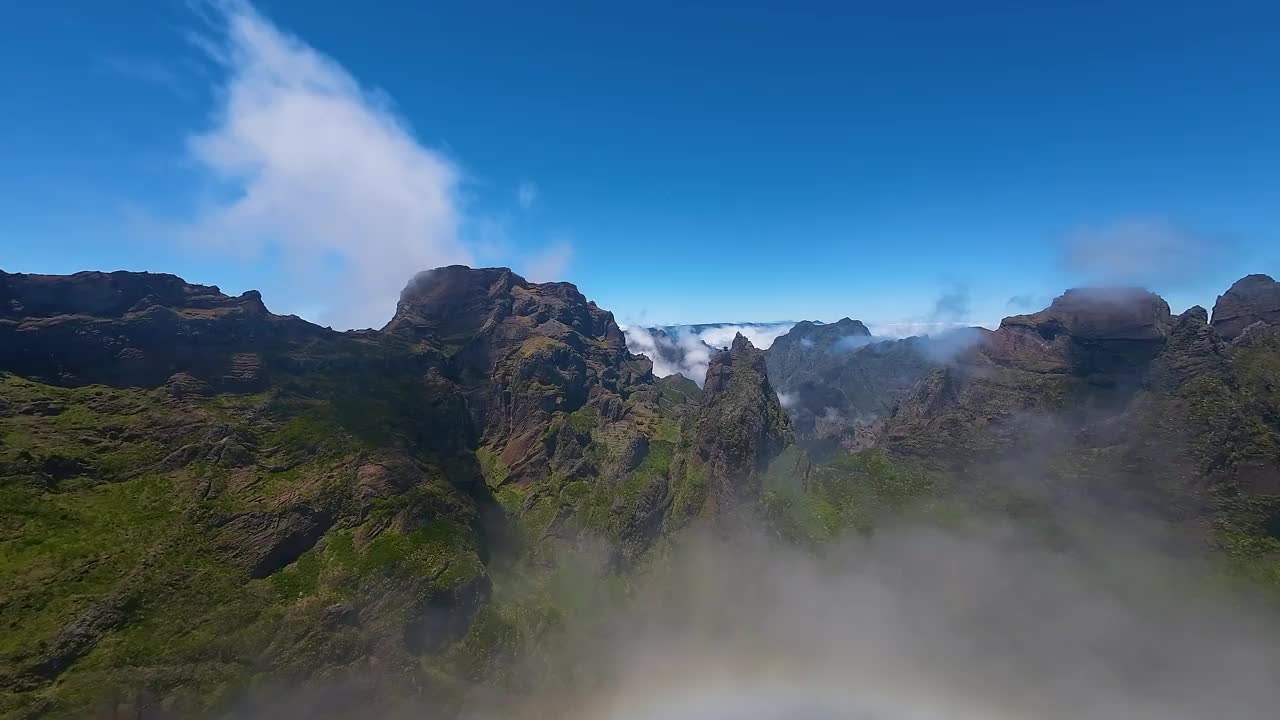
0;266;519;716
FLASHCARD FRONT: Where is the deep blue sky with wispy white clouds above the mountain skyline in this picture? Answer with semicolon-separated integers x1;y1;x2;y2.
0;0;1280;327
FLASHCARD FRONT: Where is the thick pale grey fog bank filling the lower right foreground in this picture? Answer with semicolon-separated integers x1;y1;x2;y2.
448;512;1280;720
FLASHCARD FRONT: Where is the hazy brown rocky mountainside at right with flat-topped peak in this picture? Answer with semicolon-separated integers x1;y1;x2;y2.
879;281;1280;543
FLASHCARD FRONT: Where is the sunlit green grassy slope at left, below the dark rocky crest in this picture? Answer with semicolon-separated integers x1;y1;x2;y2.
0;368;484;717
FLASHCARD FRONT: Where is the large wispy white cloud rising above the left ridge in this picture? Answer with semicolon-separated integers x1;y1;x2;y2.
187;3;471;327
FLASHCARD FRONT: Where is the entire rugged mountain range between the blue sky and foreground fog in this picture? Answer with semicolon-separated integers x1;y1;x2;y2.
0;266;1280;717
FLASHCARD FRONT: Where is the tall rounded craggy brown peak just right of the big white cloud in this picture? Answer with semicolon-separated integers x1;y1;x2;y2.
383;265;657;483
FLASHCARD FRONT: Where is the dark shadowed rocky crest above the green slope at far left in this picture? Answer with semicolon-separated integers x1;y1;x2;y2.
0;272;325;391
